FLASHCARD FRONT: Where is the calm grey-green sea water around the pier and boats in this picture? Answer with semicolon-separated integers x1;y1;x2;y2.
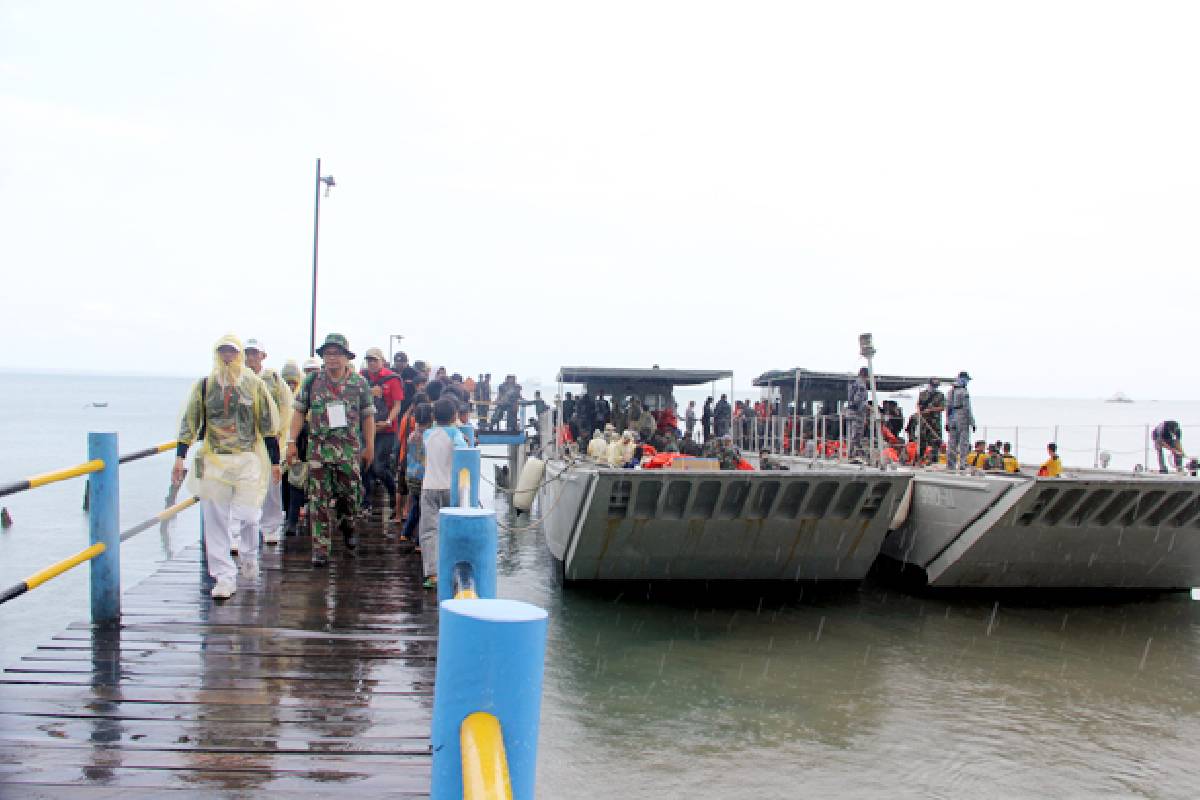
0;374;1200;799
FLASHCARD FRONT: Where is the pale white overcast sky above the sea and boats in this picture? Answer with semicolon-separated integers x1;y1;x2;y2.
0;0;1200;397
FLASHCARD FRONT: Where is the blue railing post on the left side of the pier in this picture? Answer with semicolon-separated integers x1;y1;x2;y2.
88;432;121;625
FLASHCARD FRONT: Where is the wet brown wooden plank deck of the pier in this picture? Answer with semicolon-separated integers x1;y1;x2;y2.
0;519;437;799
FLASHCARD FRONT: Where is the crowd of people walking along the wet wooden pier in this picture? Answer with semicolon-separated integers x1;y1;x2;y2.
172;333;492;599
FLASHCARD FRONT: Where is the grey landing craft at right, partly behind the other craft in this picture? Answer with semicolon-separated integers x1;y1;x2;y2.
755;371;1200;590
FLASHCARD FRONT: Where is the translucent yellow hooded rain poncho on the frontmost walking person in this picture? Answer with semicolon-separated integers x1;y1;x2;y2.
178;333;279;507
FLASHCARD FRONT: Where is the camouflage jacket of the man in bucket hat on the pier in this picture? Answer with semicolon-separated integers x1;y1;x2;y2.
295;369;374;463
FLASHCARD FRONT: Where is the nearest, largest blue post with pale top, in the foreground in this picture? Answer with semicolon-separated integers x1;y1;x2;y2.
431;600;547;800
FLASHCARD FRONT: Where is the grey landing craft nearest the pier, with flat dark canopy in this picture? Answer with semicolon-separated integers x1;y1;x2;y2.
539;367;912;582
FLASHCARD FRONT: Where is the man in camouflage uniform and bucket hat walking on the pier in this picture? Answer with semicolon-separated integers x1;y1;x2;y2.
288;333;374;566
